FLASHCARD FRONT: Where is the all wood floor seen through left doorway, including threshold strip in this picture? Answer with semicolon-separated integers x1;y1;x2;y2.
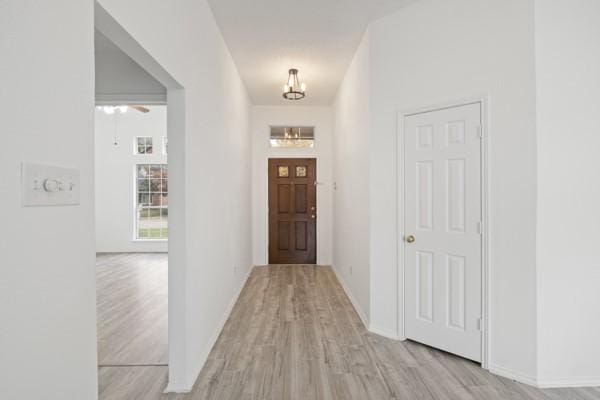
96;253;168;400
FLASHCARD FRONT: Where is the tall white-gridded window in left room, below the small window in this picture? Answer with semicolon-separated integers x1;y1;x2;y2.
135;164;169;240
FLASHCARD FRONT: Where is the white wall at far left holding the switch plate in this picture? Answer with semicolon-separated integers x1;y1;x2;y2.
0;0;97;400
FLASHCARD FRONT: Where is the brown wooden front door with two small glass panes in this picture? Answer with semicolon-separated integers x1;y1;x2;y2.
269;158;317;264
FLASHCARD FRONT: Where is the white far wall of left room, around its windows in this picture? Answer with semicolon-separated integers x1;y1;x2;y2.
94;106;168;253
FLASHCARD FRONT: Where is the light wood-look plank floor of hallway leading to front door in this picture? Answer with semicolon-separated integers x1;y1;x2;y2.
100;260;600;400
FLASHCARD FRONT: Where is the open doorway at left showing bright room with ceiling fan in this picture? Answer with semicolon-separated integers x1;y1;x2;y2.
94;31;169;398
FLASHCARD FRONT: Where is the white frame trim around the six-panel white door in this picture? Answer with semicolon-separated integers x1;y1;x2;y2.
396;95;491;369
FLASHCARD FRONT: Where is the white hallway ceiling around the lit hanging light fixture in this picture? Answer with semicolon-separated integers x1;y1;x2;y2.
208;0;414;105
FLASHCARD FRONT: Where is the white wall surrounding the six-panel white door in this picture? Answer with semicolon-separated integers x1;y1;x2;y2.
334;0;536;382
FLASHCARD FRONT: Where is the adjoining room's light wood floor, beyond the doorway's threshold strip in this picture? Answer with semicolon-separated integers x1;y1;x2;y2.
96;253;168;366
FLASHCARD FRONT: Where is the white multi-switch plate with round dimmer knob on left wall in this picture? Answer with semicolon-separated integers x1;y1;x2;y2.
21;163;79;207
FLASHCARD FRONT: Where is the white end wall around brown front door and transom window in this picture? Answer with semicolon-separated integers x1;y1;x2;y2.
252;106;333;265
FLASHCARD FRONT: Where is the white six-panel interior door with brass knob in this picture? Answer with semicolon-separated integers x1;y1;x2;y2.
404;103;482;361
